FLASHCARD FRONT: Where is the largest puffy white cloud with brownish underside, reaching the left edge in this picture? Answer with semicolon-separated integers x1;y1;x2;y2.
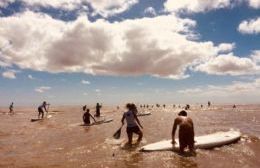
0;11;244;79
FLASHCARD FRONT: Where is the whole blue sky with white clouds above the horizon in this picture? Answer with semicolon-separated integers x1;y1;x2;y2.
0;0;260;106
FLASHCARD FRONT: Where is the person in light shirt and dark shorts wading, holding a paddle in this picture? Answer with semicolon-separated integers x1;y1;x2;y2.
121;103;143;145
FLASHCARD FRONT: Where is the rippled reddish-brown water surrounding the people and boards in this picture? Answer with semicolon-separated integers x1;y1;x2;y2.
0;105;260;168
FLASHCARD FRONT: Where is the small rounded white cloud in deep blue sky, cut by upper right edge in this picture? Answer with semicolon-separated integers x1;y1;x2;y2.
237;17;260;34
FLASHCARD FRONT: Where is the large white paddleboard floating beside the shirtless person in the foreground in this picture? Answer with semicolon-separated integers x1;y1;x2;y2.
141;130;241;151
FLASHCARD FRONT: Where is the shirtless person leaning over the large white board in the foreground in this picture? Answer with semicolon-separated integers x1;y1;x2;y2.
172;110;195;153
